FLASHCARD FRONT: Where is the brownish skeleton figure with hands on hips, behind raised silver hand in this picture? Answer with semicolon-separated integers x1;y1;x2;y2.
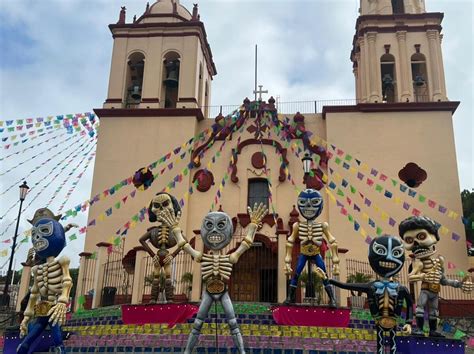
140;192;181;303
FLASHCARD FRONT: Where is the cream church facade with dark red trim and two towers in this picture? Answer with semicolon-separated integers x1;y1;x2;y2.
76;0;468;307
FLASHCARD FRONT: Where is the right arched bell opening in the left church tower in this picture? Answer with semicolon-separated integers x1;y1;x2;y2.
161;52;180;108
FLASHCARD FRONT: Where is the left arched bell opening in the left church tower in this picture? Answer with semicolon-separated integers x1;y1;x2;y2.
125;52;145;108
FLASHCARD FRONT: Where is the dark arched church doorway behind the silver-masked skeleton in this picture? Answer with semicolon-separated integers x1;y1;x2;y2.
229;234;278;303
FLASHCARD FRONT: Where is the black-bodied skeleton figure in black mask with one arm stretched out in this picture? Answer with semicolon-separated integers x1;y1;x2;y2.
329;235;413;354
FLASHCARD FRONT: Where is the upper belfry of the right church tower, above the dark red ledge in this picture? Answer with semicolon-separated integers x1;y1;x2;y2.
351;0;447;103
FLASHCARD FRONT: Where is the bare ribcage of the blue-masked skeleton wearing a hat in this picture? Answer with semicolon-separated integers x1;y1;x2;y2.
36;260;63;301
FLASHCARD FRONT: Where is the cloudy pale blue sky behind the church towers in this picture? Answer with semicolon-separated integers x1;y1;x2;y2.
0;0;474;269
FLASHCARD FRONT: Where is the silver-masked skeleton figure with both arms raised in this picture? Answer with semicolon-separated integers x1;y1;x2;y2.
159;204;267;354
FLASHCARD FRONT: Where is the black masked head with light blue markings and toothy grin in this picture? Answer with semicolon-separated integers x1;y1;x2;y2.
369;236;405;278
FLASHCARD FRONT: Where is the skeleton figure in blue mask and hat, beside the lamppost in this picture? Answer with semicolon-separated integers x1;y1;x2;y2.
17;208;77;354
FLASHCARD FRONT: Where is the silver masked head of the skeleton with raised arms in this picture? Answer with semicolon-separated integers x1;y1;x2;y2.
201;211;234;251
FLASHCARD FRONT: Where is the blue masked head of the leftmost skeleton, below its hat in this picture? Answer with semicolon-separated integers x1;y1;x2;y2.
31;219;66;259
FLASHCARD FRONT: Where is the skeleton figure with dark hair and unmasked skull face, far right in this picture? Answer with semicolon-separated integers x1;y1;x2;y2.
398;216;474;337
